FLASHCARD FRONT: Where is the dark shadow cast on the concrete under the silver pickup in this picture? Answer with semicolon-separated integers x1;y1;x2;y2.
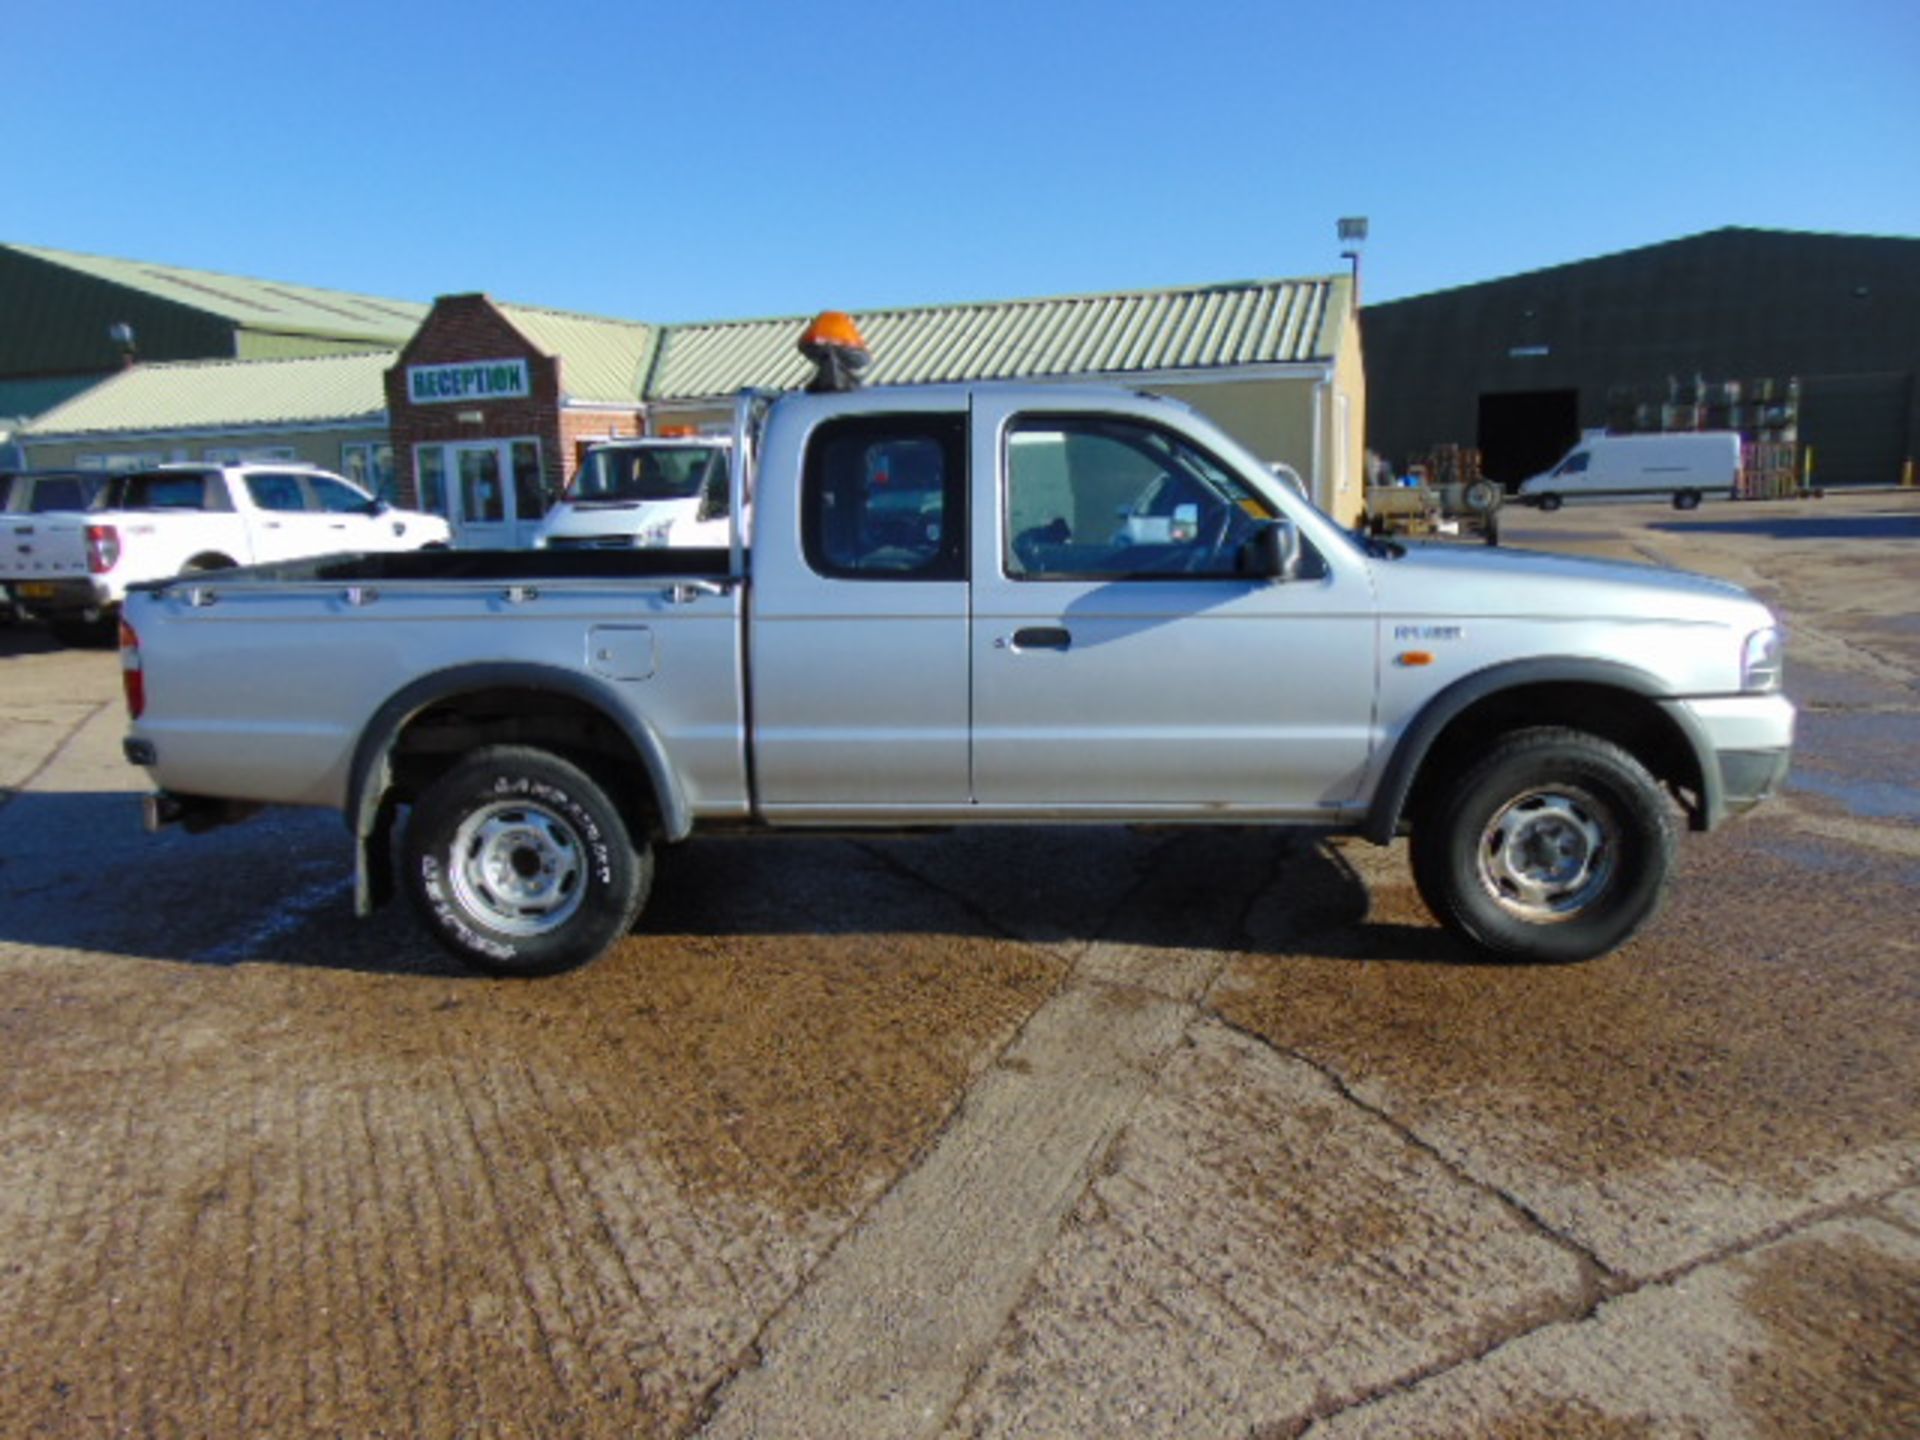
0;791;1478;977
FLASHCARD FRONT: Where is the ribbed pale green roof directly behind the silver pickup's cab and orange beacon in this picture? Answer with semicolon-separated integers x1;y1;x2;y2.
647;275;1352;399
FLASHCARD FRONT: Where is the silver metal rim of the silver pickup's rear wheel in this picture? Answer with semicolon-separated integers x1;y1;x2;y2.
451;801;588;935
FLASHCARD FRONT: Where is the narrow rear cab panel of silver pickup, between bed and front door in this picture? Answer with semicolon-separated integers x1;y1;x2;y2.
751;408;968;822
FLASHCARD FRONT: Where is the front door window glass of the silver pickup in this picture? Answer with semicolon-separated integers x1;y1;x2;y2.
1002;415;1275;580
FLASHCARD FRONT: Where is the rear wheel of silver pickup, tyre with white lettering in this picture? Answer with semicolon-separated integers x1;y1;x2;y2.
405;745;653;975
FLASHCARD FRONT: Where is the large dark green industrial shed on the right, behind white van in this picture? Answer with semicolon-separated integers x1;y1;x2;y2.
1361;228;1920;486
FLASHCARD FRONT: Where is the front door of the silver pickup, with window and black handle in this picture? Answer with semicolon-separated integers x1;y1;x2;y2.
972;396;1375;816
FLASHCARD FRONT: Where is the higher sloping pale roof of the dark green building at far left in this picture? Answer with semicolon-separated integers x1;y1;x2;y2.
8;244;428;346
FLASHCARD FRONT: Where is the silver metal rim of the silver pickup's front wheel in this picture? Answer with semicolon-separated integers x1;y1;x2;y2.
1478;785;1620;924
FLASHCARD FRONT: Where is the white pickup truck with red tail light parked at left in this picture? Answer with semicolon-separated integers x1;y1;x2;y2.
0;463;449;643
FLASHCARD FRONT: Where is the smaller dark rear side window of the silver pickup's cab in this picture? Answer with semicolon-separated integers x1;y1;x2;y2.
801;415;966;580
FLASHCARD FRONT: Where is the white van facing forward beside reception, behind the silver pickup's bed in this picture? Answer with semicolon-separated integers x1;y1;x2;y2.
534;436;733;549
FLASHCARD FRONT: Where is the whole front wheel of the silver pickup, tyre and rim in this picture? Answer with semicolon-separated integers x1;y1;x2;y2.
1411;728;1674;962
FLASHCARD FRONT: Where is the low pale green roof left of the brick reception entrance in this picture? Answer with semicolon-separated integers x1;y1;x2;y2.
19;349;394;440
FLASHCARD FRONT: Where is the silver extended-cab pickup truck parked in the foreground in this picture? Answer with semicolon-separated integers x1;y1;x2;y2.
123;386;1793;973
